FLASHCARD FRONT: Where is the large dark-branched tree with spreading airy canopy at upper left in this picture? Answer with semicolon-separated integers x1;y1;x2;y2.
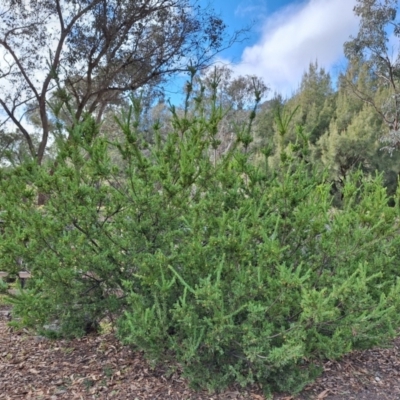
0;0;243;164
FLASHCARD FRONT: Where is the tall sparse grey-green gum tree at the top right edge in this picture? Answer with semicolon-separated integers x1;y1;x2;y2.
344;0;400;151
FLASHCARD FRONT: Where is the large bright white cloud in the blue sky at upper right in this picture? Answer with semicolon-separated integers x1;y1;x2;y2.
228;0;358;96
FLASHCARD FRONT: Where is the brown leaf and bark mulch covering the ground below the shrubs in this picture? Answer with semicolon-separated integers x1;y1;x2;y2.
0;307;400;400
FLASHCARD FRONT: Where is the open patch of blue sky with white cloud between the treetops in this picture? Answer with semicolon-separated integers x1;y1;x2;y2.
203;0;358;96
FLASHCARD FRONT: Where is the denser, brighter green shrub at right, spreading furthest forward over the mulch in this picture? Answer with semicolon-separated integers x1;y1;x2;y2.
120;156;399;392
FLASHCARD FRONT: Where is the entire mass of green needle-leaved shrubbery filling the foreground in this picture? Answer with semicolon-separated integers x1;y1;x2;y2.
0;72;400;394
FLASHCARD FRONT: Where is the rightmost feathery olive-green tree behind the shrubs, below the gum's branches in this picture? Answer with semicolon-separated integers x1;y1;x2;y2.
312;64;400;202
